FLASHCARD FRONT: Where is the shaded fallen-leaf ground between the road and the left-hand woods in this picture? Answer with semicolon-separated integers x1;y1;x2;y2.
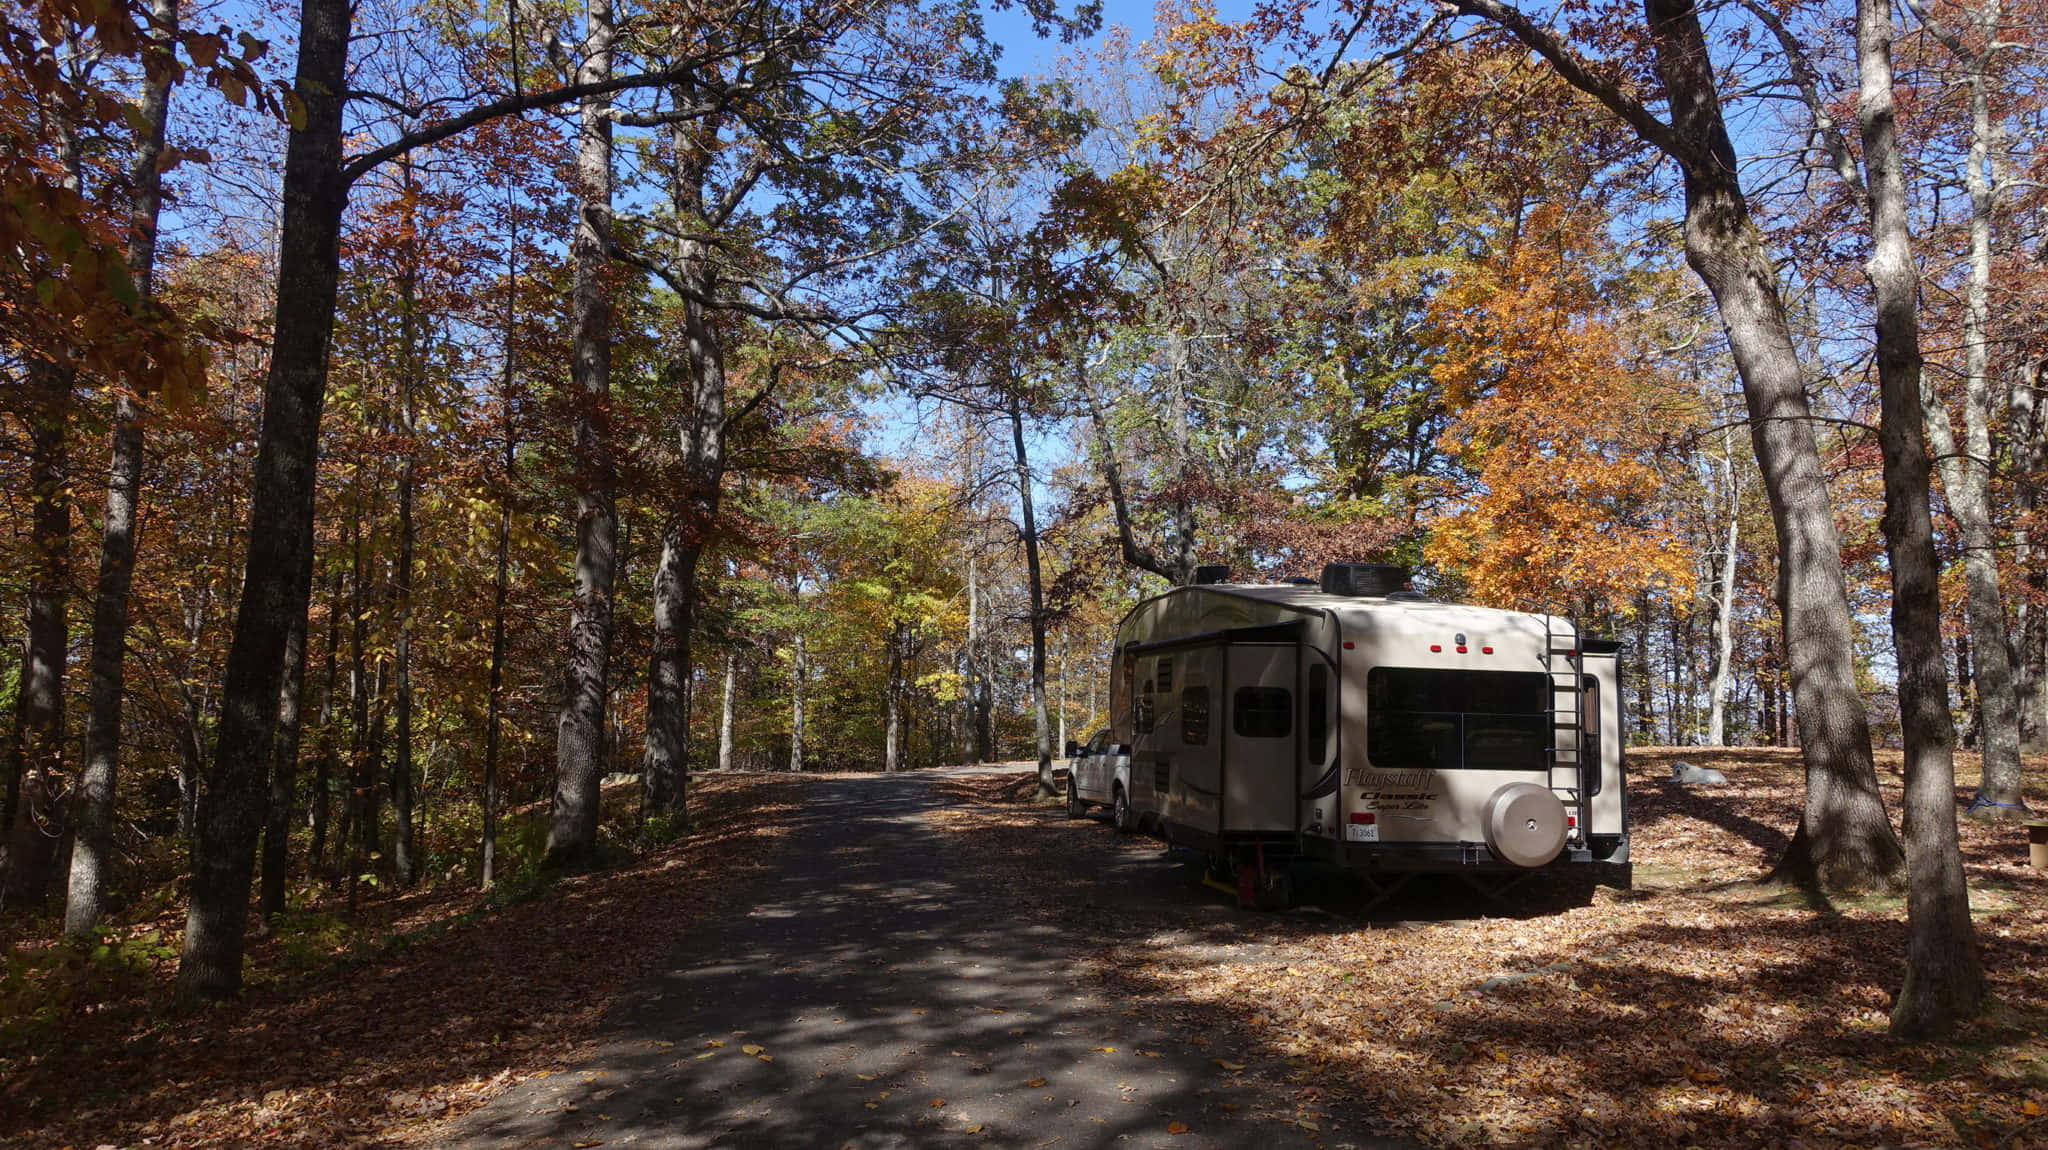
0;776;801;1148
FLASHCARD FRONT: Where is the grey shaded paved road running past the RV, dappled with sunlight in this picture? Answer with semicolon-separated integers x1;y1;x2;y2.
449;776;1407;1150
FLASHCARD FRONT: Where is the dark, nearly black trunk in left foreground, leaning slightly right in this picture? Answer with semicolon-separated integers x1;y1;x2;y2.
178;0;352;997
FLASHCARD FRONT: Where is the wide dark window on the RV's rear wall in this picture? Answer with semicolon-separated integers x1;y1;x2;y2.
1366;667;1550;771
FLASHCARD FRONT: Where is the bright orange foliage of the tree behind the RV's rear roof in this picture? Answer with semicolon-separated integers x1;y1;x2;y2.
1427;207;1694;606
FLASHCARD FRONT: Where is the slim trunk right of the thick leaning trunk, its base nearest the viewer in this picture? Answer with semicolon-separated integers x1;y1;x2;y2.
1855;0;2005;1037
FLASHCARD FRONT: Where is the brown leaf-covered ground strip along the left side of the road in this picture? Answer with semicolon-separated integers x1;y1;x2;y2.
0;778;797;1148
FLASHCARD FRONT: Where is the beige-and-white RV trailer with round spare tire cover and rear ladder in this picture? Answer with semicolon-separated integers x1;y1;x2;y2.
1110;563;1628;904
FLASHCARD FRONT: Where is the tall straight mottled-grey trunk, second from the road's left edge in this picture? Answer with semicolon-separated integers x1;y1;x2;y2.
547;0;618;866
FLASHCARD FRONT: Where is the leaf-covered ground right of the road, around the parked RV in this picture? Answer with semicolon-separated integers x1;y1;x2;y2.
938;749;2048;1150
